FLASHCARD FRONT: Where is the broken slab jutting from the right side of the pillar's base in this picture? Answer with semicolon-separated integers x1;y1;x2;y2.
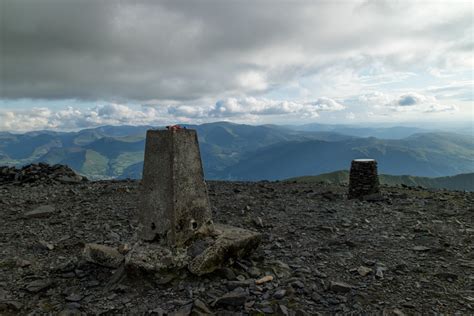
188;224;261;275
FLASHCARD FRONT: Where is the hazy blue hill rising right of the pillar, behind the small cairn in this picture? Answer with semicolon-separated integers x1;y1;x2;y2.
220;133;474;180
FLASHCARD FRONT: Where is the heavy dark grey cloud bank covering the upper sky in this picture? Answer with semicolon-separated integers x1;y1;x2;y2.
0;0;472;102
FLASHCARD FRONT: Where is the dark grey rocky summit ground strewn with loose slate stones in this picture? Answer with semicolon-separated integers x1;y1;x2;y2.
0;177;474;315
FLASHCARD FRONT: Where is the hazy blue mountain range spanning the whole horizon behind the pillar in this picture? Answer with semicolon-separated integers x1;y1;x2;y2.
0;122;474;180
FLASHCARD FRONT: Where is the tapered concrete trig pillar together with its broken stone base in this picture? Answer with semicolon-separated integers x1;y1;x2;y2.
84;125;261;276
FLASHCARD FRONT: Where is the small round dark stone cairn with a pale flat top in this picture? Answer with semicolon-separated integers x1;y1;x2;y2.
349;159;380;199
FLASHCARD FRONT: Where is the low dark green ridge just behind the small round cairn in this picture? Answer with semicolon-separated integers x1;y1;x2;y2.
288;170;474;192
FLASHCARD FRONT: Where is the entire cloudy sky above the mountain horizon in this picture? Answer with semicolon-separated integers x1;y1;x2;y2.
0;0;474;131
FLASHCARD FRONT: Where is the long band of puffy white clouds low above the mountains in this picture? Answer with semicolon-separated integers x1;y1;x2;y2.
0;97;345;131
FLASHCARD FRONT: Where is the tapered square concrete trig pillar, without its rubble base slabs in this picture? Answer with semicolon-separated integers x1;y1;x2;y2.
139;129;212;247
